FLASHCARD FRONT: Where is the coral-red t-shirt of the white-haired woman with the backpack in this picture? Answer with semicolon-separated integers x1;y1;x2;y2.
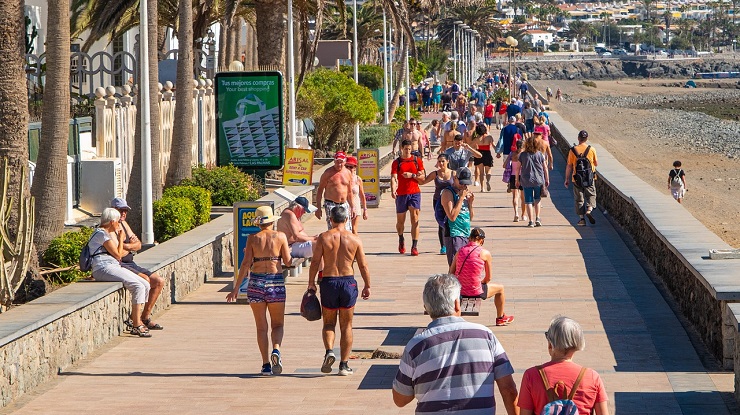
517;361;608;415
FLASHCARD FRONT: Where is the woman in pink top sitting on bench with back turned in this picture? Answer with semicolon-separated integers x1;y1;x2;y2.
450;228;514;326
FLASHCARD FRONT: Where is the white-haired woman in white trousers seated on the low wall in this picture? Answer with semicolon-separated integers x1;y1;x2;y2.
88;208;152;337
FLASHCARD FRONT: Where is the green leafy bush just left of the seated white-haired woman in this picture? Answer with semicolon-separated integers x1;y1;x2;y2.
43;228;95;284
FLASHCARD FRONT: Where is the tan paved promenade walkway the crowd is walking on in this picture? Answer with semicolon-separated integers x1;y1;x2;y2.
6;122;737;415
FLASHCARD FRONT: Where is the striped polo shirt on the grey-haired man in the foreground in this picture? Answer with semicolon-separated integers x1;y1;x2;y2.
393;316;514;415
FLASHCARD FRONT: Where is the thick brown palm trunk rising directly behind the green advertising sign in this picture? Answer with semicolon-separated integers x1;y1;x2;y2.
254;0;288;68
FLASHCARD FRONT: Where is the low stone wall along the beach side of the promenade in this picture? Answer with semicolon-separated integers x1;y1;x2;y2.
551;117;740;369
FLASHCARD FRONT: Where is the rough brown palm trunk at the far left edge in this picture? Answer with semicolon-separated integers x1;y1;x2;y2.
0;0;30;234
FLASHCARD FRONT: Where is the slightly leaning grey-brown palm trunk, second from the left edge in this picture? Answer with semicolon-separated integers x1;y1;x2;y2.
31;0;70;252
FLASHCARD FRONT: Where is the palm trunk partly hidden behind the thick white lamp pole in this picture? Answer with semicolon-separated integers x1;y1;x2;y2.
126;0;162;232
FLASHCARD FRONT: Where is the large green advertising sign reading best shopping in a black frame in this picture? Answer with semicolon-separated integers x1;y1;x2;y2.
216;71;285;170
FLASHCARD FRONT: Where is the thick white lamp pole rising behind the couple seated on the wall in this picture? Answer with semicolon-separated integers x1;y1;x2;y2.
139;0;154;245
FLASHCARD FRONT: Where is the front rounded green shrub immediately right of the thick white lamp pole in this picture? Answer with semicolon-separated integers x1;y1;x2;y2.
154;196;196;242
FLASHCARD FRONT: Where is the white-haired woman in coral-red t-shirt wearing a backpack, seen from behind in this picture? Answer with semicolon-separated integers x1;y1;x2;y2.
517;316;609;415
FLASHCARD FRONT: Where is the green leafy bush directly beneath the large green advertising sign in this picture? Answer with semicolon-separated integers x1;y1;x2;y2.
181;165;264;206
